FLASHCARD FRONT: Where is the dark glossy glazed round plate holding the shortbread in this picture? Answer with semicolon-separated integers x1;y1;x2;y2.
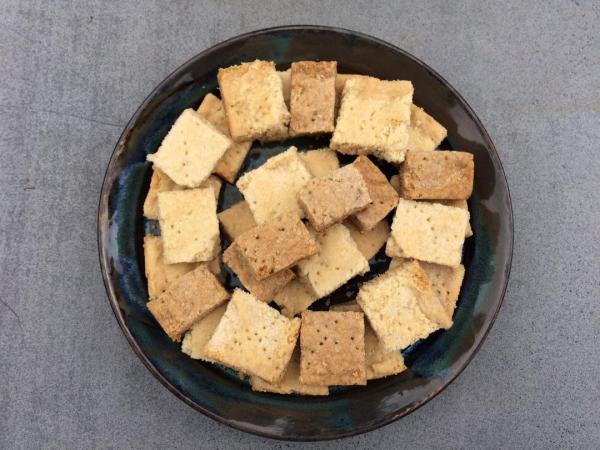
98;26;513;440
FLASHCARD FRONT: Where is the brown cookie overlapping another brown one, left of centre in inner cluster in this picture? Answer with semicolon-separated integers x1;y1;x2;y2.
235;213;319;280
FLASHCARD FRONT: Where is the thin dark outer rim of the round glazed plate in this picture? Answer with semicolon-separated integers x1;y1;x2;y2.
97;25;515;442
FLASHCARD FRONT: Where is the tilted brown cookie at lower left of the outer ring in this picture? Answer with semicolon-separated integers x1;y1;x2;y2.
147;264;229;341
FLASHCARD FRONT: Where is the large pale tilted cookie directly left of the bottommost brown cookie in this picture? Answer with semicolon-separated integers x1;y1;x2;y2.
204;289;300;383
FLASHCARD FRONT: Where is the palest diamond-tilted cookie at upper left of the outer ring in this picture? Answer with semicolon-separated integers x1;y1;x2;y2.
147;108;232;188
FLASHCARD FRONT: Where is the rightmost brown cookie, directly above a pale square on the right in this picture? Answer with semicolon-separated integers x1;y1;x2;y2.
400;150;475;200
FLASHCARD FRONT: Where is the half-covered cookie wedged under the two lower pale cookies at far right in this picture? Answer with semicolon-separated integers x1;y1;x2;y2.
390;258;465;317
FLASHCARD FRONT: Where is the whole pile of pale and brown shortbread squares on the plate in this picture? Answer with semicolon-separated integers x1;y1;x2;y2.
139;61;474;395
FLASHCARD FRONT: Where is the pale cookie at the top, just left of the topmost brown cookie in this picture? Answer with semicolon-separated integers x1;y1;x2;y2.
217;60;290;142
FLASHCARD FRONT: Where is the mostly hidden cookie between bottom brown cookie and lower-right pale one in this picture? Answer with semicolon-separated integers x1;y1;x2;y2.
330;301;406;380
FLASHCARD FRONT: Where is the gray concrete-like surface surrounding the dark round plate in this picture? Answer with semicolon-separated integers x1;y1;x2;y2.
0;0;600;449
